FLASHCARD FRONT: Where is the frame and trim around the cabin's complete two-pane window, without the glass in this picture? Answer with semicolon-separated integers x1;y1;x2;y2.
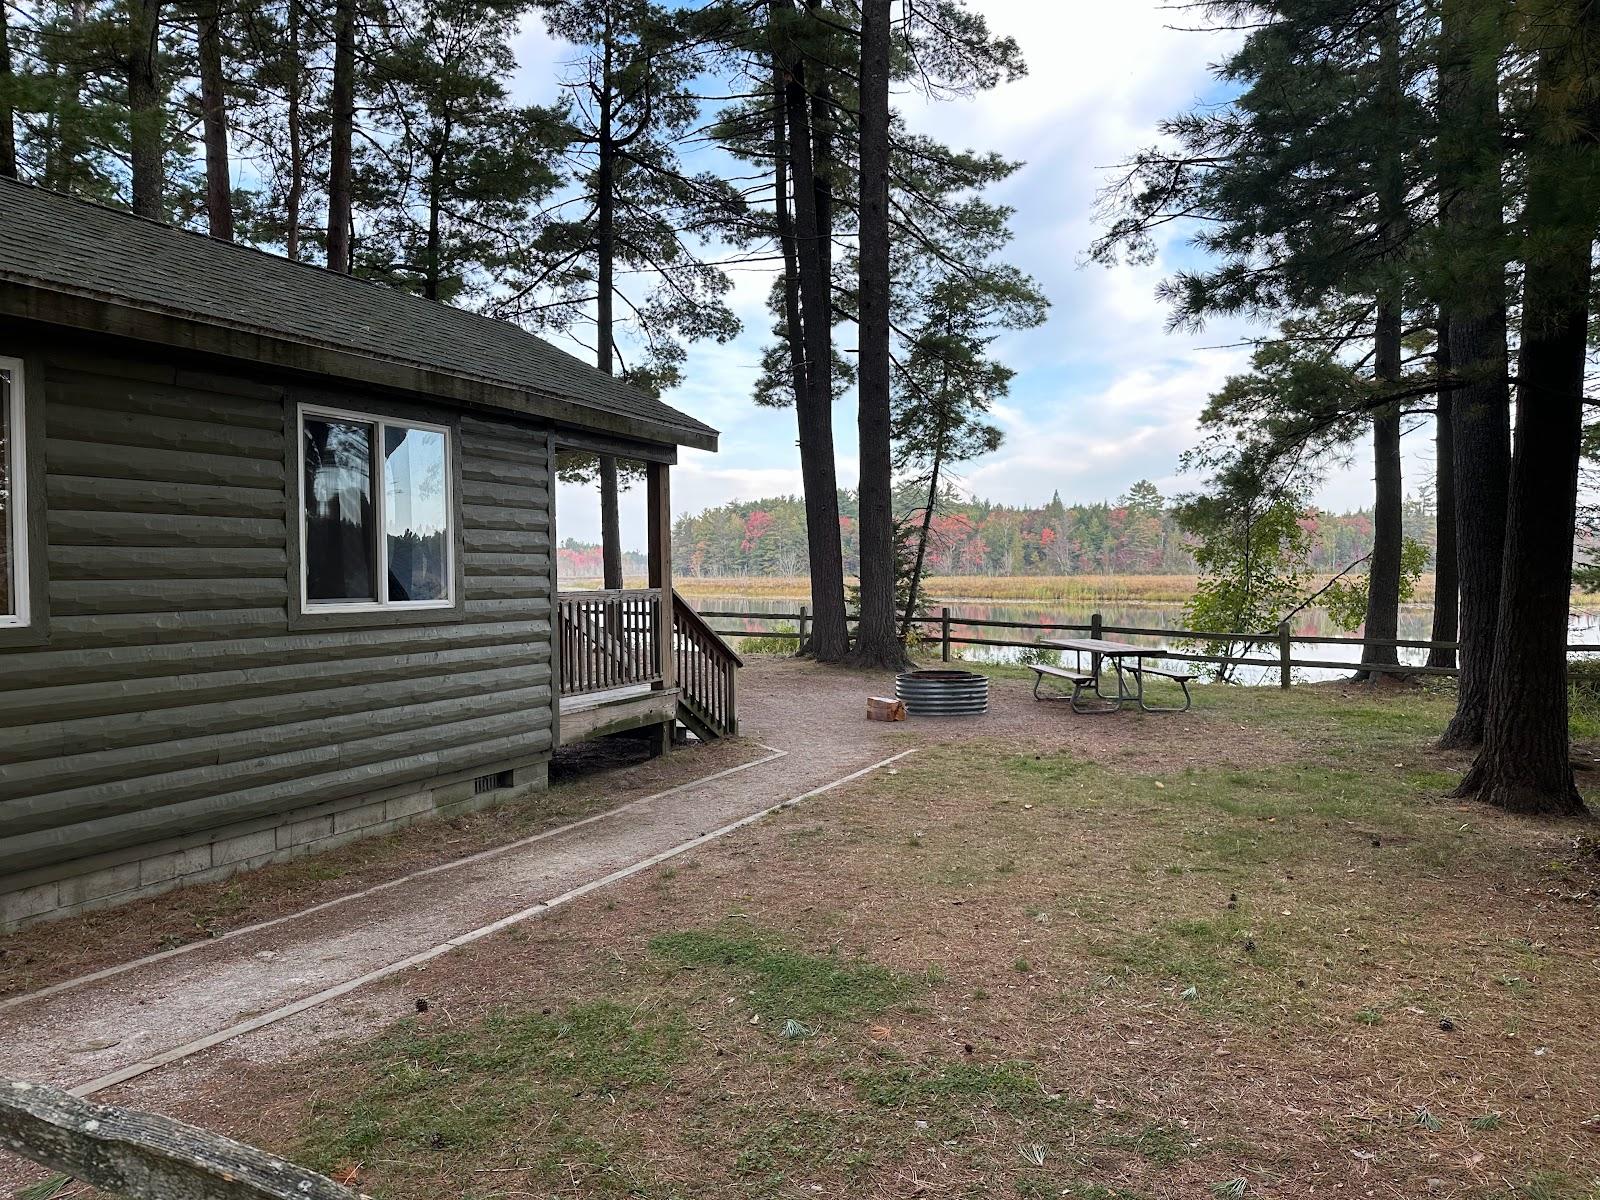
294;403;458;616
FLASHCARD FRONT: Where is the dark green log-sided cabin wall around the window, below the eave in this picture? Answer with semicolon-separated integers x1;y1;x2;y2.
0;339;555;928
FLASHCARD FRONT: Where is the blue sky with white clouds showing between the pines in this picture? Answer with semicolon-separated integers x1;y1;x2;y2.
515;0;1430;549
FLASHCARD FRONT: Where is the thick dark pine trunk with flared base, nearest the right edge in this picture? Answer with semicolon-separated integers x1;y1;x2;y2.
1456;5;1600;814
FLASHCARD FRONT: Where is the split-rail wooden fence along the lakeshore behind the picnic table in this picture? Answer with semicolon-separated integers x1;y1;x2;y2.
701;605;1600;688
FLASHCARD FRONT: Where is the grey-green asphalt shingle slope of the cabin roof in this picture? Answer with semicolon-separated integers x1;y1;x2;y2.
0;179;717;442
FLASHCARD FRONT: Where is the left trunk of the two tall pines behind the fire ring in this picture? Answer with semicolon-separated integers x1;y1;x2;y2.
784;2;850;662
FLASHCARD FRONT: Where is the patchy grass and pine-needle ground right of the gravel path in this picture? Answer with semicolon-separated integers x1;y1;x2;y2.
3;661;1600;1200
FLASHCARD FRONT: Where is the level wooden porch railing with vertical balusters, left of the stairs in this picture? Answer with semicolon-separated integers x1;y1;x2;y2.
555;587;661;696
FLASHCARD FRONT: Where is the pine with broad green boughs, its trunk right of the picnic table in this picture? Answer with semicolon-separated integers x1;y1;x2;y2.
1094;0;1432;678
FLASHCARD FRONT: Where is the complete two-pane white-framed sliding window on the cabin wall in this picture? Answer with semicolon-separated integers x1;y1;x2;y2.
299;408;454;611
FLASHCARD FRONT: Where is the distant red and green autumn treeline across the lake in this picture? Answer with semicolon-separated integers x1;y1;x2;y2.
672;482;1434;576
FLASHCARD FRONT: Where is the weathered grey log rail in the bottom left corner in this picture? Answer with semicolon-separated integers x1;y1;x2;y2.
0;1080;365;1200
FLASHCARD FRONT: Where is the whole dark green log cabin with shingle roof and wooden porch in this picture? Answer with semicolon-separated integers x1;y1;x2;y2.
0;179;738;930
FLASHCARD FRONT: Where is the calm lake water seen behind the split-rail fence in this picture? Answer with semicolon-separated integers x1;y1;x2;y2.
691;595;1600;683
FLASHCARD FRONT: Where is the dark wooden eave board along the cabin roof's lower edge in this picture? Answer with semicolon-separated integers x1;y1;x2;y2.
0;275;717;451
